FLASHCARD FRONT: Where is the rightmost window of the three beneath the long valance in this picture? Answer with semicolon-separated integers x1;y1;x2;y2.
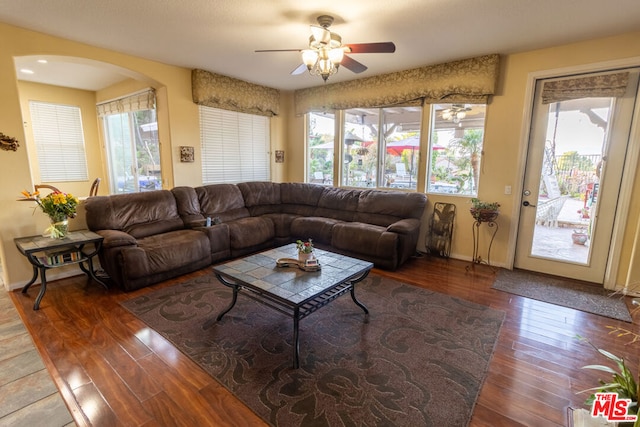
427;104;486;196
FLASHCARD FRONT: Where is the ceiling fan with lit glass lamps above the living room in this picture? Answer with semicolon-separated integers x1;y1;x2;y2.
256;15;396;82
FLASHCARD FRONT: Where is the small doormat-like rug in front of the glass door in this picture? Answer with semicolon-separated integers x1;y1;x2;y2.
491;269;632;322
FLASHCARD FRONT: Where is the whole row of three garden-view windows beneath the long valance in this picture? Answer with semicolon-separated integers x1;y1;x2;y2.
307;104;486;197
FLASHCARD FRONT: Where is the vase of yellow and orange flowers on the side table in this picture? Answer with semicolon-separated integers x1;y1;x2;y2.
22;191;78;239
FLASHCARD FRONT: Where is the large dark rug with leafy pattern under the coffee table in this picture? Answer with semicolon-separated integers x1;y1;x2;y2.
123;274;504;427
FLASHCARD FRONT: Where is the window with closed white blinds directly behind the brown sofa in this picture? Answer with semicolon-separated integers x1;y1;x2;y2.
200;106;271;184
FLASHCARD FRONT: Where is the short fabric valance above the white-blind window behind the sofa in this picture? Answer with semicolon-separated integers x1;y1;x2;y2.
191;70;280;117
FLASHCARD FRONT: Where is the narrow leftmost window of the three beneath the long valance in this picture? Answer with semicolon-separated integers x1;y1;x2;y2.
307;113;336;185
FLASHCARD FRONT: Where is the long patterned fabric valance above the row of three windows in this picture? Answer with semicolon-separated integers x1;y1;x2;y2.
294;54;500;115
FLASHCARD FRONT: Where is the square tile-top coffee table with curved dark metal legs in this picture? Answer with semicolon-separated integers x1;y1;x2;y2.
204;244;373;368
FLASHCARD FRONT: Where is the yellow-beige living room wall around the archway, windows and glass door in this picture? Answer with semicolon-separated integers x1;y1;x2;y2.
0;20;640;294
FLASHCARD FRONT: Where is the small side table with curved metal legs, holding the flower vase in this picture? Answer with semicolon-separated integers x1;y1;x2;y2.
13;230;109;310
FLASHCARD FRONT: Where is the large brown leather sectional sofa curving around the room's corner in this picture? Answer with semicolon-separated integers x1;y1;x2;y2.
85;182;427;291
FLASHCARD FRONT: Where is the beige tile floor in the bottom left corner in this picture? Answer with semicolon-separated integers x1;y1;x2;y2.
0;286;76;427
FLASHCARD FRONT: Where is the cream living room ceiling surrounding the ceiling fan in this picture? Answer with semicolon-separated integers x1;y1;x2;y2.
0;0;640;90
